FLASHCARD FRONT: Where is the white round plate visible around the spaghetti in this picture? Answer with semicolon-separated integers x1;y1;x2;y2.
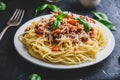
14;14;115;69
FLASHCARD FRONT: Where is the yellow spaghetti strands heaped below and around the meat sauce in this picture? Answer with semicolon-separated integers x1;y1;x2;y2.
19;13;107;65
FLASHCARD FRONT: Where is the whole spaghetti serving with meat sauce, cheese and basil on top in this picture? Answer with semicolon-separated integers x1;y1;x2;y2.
19;12;108;65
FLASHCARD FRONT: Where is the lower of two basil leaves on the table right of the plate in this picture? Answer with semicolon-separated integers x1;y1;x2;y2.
97;19;116;31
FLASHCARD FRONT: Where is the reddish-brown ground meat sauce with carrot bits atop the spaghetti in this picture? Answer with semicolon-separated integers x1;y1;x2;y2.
34;13;95;45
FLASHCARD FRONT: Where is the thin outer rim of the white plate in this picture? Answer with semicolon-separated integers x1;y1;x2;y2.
14;14;115;69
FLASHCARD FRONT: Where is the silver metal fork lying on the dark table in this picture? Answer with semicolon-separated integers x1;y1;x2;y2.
0;9;25;40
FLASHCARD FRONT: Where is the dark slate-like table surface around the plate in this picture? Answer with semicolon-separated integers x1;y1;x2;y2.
0;0;120;80
